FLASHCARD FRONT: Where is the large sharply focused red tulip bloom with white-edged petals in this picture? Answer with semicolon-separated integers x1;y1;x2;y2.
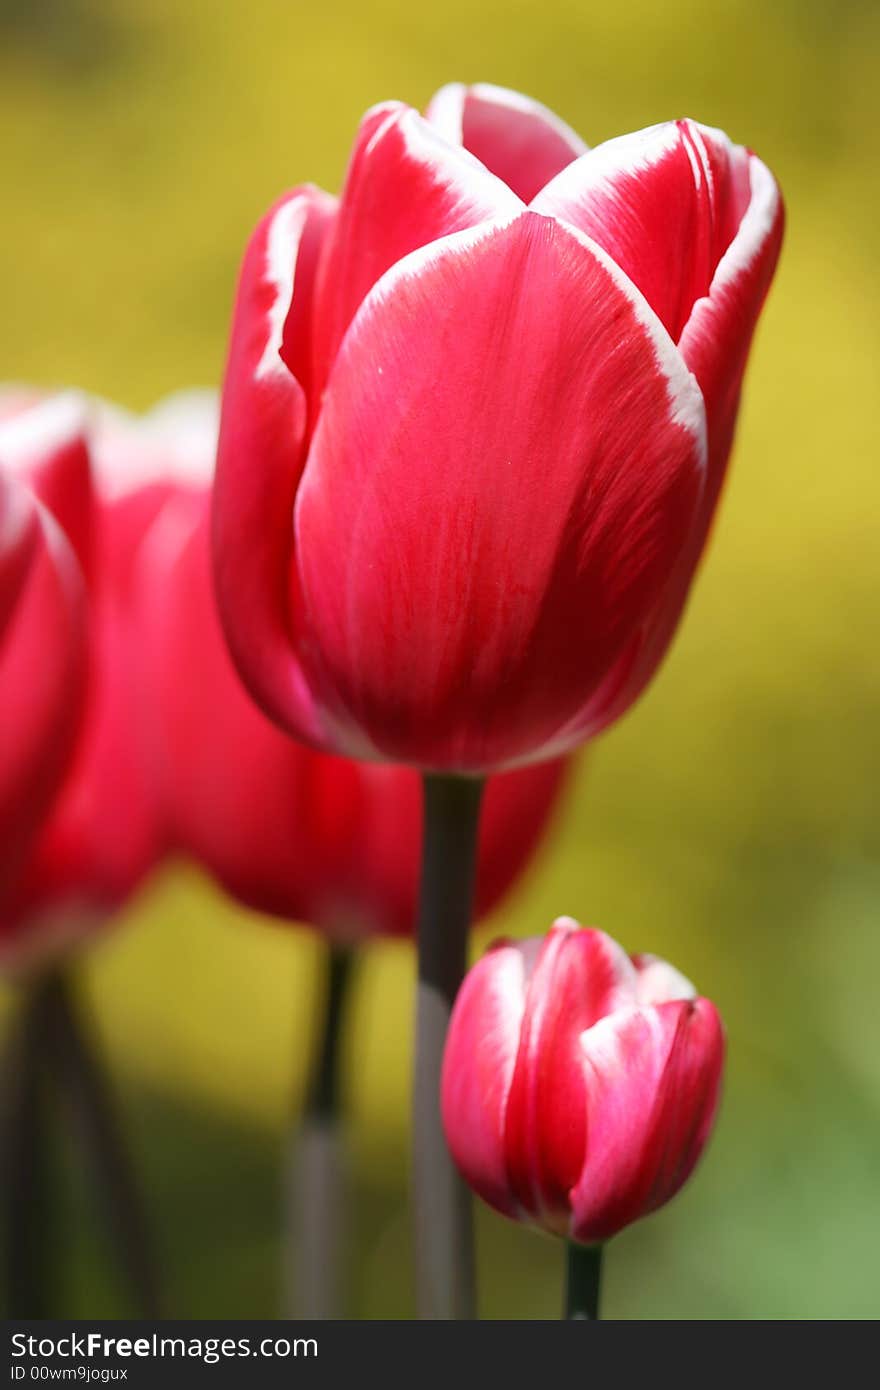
214;78;783;773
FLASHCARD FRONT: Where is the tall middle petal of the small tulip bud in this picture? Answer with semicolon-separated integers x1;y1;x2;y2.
505;917;637;1233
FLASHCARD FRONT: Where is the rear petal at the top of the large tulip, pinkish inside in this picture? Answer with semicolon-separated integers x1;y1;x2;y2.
425;82;587;203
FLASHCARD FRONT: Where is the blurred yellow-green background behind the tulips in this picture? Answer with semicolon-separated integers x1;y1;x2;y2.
0;0;880;1318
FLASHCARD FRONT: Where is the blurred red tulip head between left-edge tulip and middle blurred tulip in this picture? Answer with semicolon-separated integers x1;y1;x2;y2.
0;399;213;966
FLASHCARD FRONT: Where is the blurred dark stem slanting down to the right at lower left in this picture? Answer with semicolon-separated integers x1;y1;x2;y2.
44;972;160;1318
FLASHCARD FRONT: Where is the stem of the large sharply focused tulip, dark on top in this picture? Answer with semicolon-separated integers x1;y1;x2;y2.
413;776;484;1319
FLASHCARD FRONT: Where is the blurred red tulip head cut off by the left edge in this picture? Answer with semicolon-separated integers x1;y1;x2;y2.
0;398;89;899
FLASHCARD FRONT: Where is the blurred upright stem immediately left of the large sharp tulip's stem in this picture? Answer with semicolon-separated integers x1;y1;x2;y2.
285;945;355;1319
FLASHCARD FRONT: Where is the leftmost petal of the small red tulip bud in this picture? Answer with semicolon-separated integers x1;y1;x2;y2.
441;938;541;1216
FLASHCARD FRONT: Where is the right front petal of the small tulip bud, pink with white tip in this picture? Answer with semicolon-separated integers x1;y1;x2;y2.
569;999;724;1244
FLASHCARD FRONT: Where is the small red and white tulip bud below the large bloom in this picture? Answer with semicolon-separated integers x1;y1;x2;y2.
442;917;724;1244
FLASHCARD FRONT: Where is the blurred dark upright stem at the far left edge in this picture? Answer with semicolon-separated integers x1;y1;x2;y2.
0;980;61;1318
